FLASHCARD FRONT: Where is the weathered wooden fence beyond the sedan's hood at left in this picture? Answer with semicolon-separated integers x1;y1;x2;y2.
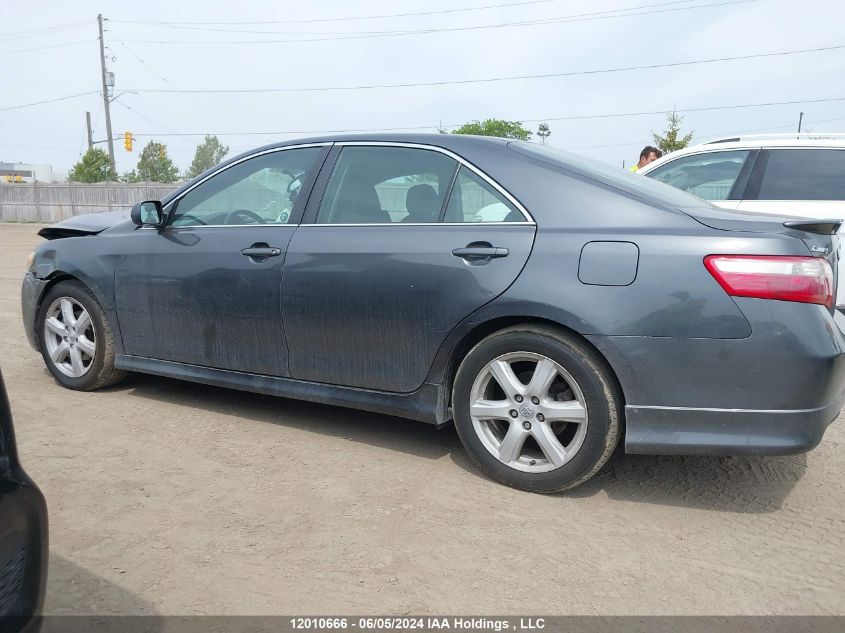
0;182;178;223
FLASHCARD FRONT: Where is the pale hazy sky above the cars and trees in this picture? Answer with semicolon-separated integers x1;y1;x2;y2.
0;0;845;173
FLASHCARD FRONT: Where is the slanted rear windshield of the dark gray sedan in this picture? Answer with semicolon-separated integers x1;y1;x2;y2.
508;141;709;207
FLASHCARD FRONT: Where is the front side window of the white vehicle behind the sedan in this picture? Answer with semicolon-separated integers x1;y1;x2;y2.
647;150;750;200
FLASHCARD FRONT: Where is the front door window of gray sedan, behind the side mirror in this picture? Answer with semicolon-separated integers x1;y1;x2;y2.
170;147;321;227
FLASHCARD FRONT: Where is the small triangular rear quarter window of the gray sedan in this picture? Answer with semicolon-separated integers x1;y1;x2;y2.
443;166;527;222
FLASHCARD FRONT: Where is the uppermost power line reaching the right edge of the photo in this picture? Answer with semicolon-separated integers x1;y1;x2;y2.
125;44;845;94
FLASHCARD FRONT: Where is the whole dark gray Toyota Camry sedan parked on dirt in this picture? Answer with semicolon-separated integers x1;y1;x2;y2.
23;135;845;492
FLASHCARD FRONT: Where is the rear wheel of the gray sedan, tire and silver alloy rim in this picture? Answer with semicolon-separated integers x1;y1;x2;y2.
452;325;623;493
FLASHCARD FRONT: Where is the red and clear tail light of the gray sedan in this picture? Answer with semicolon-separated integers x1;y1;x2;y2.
704;255;833;308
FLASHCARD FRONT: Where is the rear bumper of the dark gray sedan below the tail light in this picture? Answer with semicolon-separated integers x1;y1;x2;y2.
588;299;845;455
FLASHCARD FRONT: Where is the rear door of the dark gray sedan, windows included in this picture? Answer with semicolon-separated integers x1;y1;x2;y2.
282;143;535;393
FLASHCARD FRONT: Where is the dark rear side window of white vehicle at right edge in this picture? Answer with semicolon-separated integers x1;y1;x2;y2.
757;149;845;200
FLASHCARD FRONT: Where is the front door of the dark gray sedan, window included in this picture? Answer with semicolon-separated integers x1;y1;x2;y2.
115;146;329;376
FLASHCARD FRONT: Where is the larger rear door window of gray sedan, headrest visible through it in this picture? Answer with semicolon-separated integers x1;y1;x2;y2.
317;146;457;224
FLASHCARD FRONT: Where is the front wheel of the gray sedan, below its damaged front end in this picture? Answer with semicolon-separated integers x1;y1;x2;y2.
35;281;126;391
